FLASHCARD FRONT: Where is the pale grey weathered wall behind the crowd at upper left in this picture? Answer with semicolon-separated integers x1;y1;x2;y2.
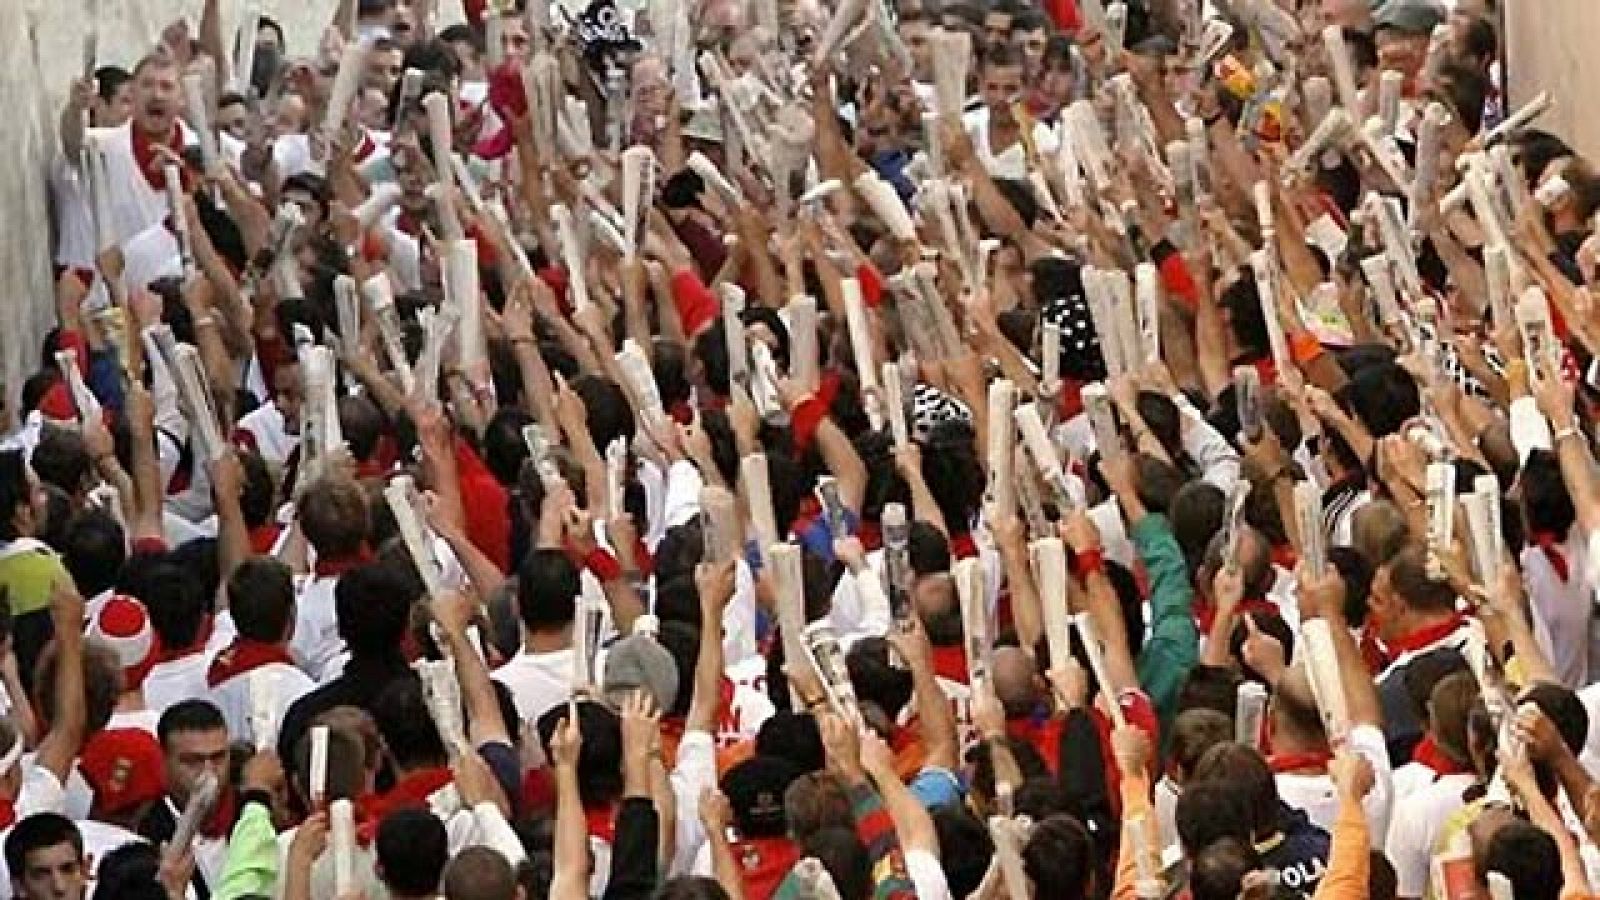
0;0;461;408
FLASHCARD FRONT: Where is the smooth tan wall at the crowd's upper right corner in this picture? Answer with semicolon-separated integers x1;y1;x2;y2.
1501;0;1600;160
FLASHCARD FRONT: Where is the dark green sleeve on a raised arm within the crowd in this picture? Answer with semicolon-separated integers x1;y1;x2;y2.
1131;512;1200;735
